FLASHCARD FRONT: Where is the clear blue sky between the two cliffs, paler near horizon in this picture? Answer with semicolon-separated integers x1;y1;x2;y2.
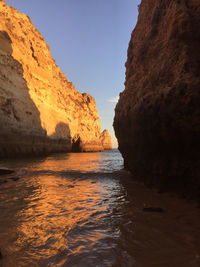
5;0;140;147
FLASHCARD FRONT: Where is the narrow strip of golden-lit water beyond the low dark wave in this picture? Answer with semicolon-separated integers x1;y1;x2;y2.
0;150;123;174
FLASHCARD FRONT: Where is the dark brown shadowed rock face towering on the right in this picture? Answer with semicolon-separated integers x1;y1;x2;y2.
114;0;200;197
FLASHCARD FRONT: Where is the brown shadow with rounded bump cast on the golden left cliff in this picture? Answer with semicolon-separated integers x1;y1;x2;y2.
0;31;71;157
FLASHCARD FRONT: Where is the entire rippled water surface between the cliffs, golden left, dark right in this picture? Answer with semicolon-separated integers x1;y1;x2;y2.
0;150;200;267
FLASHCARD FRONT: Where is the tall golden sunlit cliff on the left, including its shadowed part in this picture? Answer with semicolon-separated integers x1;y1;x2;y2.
0;0;111;156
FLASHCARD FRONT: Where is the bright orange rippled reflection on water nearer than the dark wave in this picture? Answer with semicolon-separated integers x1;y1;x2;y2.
10;176;119;263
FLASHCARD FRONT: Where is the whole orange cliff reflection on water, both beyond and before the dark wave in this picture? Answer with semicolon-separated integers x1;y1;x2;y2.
0;153;123;266
